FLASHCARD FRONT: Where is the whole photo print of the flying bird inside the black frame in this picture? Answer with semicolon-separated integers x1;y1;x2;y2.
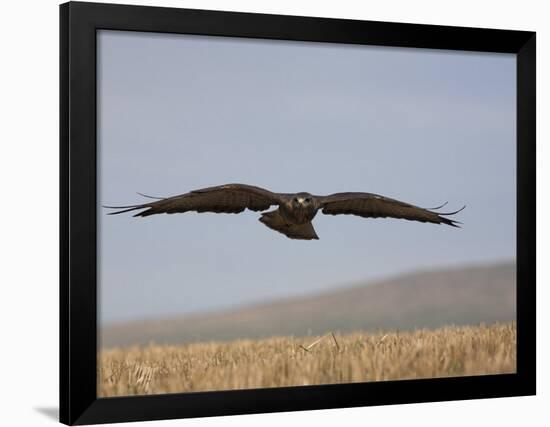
97;30;516;397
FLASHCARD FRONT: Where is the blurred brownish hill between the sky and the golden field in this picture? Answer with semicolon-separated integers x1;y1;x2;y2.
100;262;516;348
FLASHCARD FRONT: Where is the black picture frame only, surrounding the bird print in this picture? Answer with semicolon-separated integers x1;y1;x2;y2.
60;2;536;425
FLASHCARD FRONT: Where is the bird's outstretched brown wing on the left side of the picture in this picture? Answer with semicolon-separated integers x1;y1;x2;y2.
104;184;281;216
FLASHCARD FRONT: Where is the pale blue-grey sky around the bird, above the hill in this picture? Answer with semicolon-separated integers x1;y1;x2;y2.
98;31;516;323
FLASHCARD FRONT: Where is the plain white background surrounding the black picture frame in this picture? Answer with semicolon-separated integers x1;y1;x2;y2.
0;0;550;427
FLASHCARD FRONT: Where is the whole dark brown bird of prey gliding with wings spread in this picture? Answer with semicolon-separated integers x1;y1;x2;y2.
104;184;465;240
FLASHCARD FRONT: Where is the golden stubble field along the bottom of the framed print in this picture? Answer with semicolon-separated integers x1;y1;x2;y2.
98;323;516;397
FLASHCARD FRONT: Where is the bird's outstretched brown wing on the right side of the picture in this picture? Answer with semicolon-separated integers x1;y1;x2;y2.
318;193;466;227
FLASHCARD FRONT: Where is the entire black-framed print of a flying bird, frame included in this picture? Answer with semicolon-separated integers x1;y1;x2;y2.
60;2;535;424
